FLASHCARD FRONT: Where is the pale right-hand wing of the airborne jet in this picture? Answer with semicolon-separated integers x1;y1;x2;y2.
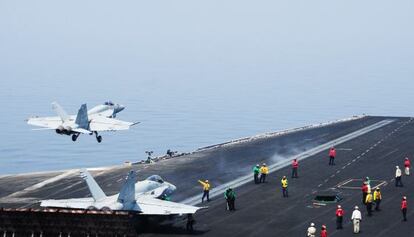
89;116;136;132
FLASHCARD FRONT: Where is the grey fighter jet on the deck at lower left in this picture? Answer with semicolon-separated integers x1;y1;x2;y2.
40;169;203;216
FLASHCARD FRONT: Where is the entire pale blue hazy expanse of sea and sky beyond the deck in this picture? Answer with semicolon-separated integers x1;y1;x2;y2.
0;1;414;175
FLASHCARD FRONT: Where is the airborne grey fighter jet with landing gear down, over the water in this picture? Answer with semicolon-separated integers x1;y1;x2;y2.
27;102;137;142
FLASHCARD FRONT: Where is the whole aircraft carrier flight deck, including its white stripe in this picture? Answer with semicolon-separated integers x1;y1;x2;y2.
0;116;414;237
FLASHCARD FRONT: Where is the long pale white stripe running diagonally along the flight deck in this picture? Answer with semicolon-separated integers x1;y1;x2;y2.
181;119;395;205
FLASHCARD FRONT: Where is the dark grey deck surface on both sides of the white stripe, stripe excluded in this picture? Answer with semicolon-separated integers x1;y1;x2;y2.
0;117;414;236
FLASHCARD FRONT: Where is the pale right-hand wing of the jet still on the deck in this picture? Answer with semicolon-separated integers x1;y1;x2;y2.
136;196;205;215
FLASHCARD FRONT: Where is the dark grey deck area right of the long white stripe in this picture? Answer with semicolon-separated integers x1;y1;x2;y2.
146;116;414;237
